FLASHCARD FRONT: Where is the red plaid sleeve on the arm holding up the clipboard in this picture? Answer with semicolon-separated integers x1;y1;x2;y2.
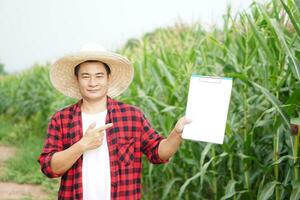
141;113;169;164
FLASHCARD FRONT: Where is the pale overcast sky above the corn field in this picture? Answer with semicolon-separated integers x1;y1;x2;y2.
0;0;262;73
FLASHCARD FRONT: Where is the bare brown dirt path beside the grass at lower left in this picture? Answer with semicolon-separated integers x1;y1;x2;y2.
0;145;48;200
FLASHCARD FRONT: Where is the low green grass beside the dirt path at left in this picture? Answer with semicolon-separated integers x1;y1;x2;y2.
0;116;59;199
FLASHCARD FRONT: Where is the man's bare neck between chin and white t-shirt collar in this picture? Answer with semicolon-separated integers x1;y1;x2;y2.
81;96;107;114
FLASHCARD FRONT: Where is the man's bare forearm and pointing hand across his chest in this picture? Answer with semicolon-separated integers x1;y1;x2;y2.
51;123;113;175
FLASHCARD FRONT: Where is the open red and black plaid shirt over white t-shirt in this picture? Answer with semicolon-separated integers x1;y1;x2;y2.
38;97;167;199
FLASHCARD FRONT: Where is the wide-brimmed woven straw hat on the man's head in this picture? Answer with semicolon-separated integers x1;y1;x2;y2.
50;44;134;99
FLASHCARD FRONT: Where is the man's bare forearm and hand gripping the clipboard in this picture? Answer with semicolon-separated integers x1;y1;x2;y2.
158;117;191;160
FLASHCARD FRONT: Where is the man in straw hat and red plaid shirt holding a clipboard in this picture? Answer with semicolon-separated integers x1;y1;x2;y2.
39;45;190;200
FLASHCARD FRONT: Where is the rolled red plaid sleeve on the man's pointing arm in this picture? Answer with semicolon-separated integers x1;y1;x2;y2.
38;112;63;178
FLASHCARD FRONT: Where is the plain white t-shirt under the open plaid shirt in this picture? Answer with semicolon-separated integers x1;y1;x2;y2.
81;110;111;200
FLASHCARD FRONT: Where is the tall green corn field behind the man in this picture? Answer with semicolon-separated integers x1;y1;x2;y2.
0;0;300;200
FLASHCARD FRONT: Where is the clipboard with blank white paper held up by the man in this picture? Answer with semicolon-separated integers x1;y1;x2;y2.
182;74;232;144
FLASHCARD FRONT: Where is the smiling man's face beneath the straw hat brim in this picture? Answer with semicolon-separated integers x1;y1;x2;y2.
77;62;109;101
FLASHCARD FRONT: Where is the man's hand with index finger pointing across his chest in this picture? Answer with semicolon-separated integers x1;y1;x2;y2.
78;122;113;152
